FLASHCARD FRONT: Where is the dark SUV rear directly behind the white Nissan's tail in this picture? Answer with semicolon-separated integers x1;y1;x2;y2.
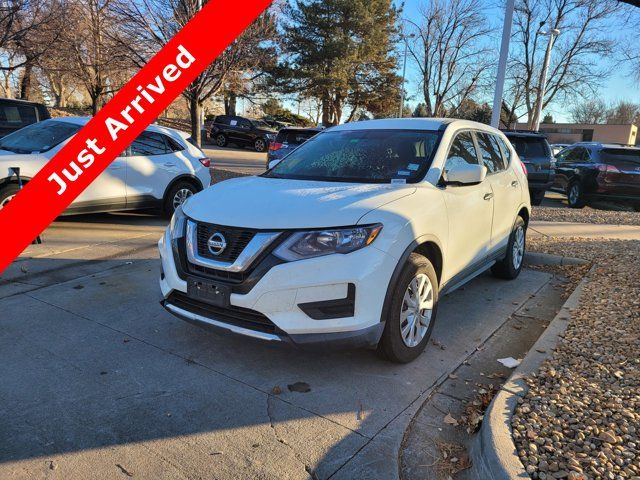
503;130;556;205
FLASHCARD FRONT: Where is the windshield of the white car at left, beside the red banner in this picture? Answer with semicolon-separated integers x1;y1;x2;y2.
0;120;81;153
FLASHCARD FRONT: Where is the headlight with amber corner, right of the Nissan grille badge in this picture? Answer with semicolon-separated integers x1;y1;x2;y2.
273;224;382;262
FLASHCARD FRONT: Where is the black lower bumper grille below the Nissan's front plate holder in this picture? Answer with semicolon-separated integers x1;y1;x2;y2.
167;292;283;335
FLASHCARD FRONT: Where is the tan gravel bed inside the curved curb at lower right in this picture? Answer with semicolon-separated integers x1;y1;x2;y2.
512;238;640;480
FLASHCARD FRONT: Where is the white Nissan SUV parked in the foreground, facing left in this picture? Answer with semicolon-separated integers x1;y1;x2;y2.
159;119;531;362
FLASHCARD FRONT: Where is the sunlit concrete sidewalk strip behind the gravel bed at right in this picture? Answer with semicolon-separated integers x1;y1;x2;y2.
529;220;640;240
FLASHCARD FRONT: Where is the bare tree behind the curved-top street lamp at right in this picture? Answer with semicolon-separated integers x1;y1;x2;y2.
510;0;620;128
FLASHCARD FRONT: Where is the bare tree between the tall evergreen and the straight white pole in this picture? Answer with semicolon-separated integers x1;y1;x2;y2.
407;0;491;116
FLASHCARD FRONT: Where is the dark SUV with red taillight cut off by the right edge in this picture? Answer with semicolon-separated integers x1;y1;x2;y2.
552;142;640;211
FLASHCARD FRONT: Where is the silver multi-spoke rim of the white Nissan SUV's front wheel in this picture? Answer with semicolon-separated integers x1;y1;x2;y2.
400;273;434;348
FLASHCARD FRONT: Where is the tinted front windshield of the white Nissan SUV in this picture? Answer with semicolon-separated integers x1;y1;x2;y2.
264;130;440;183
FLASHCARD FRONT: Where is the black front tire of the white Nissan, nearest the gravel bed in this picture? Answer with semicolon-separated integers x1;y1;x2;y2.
378;253;438;363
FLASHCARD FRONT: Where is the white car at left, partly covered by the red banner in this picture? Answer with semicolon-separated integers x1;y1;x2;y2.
0;117;211;215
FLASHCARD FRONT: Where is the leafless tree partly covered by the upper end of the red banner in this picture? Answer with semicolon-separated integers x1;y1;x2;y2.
118;0;275;144
